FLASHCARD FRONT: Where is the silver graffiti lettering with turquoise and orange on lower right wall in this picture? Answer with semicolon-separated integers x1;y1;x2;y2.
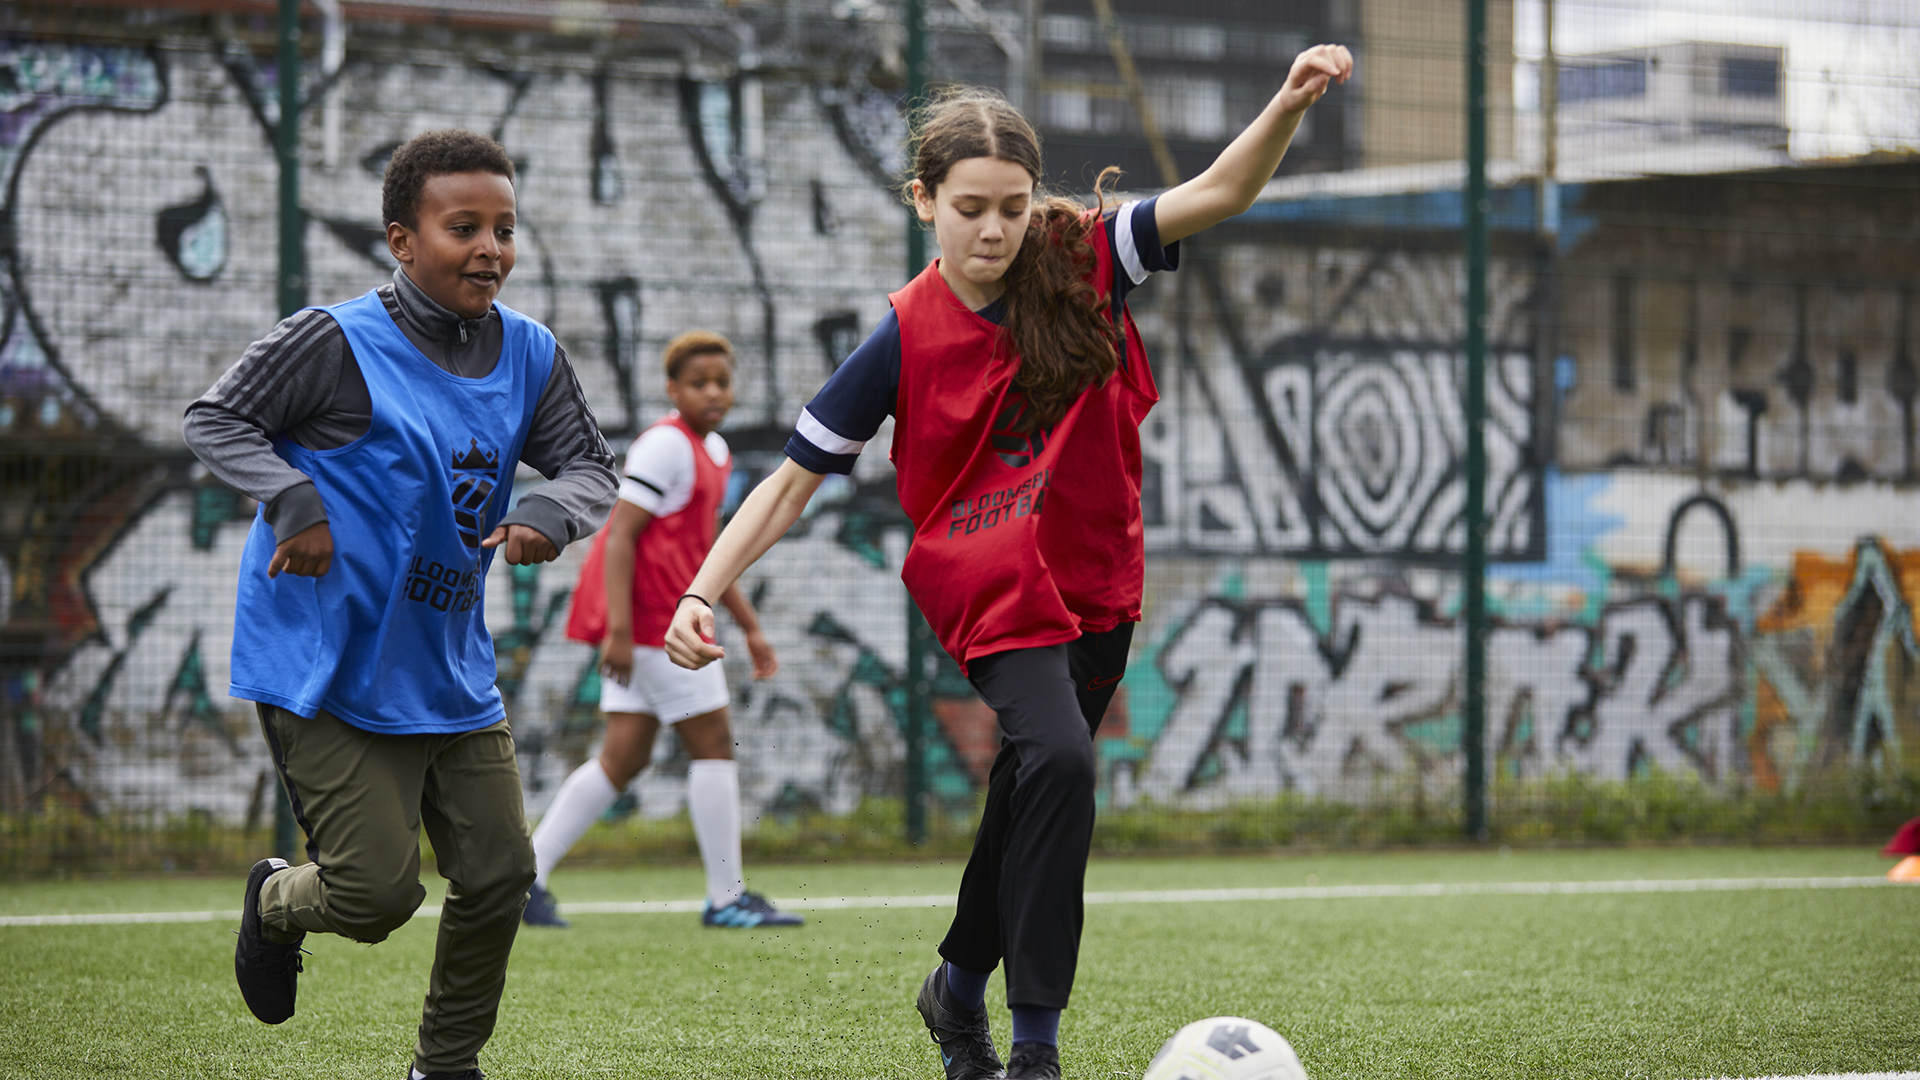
1104;473;1920;805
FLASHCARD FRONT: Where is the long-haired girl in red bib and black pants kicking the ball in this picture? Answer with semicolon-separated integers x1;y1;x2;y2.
666;44;1354;1080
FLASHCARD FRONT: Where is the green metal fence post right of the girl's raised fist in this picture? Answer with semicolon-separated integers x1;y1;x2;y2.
1461;0;1488;840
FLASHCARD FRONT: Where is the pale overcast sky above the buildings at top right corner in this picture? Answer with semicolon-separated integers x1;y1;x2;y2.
1513;0;1920;158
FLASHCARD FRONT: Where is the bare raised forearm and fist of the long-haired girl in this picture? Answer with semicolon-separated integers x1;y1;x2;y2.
1154;44;1354;244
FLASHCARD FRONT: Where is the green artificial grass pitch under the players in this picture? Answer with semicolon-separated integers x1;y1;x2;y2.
0;847;1920;1080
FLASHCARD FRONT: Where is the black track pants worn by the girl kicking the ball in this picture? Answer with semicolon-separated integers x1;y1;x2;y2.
941;623;1133;1009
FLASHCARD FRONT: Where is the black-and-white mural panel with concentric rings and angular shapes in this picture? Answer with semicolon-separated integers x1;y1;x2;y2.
1140;242;1544;561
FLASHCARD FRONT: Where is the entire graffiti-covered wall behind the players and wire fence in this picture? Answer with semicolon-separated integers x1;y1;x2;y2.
0;10;1920;824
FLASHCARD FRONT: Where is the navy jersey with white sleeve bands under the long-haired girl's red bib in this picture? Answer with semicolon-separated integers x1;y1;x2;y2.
787;198;1181;475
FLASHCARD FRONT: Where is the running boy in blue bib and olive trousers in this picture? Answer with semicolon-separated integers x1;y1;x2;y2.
186;131;616;1080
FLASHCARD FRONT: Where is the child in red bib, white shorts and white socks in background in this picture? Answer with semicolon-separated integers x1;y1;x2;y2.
522;331;801;928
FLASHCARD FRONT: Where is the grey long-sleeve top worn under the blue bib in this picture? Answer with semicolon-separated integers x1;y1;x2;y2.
184;269;618;548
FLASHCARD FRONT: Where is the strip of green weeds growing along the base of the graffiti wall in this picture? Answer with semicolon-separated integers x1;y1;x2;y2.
0;771;1920;880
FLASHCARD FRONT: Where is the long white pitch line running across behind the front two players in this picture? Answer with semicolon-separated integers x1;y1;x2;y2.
0;864;1896;926
